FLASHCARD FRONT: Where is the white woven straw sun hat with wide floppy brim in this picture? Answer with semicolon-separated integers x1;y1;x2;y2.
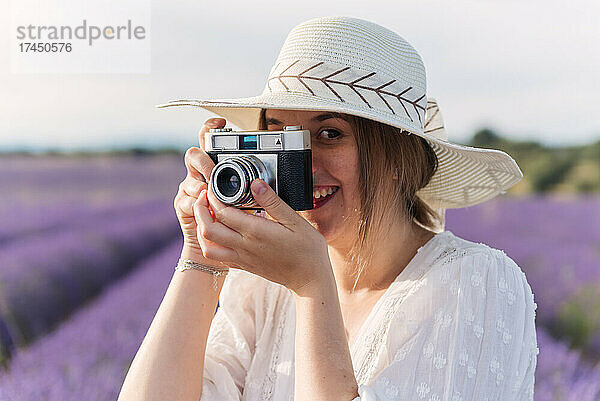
156;16;523;231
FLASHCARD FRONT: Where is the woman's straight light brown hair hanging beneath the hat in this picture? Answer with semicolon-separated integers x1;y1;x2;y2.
258;109;441;290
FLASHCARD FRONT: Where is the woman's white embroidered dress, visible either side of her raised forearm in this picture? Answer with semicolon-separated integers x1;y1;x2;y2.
201;230;539;401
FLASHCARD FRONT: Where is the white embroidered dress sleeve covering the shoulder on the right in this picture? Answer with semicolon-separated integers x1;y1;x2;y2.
353;247;539;401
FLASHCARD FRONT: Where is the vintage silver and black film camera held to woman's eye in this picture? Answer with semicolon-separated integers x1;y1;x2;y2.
204;125;313;210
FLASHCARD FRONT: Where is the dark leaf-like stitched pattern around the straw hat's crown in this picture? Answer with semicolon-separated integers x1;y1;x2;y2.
267;60;425;124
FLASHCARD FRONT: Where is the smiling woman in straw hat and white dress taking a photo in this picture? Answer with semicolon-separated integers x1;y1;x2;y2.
119;17;537;401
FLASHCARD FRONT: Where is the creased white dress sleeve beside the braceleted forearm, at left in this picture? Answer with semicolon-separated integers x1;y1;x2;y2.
200;269;268;401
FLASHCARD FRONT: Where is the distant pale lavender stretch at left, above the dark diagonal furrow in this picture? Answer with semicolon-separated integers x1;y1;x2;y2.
0;155;185;246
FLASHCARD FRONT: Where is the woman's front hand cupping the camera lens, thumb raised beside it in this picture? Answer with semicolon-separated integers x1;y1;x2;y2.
193;179;333;295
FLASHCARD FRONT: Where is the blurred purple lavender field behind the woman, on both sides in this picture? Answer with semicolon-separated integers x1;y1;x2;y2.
0;155;600;401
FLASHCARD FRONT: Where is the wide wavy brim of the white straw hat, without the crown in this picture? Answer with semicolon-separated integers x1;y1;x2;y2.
156;92;523;209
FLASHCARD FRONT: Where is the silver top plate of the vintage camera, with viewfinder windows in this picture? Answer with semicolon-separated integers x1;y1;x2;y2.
204;125;310;152
